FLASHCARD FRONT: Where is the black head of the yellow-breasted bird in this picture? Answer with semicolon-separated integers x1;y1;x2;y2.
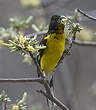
49;15;66;33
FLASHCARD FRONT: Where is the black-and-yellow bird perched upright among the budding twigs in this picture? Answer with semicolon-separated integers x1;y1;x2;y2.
37;15;67;106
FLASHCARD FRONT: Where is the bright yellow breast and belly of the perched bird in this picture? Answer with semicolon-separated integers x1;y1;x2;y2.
40;34;65;75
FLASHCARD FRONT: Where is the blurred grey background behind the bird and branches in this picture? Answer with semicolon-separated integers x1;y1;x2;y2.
0;0;96;110
